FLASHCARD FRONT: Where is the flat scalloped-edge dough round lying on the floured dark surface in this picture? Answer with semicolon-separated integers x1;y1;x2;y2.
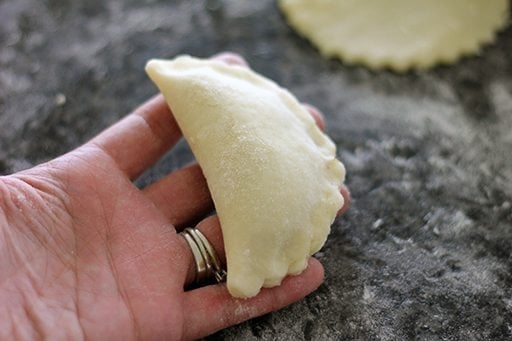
279;0;509;71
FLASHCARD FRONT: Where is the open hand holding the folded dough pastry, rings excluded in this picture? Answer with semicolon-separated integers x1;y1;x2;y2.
0;54;349;340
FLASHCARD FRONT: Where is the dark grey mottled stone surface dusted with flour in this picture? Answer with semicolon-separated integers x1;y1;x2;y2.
0;0;512;340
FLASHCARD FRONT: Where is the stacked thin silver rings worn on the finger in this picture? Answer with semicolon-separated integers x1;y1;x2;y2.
181;227;227;284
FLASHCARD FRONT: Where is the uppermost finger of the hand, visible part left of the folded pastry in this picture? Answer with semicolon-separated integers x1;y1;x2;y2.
86;95;181;180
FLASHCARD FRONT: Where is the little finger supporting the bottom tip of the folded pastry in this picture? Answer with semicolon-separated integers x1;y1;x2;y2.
183;258;324;340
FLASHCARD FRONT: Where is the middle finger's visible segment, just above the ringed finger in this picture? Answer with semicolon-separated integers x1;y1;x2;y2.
144;164;213;229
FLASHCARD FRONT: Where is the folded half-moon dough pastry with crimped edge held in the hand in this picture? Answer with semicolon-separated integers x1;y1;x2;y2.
146;56;345;297
